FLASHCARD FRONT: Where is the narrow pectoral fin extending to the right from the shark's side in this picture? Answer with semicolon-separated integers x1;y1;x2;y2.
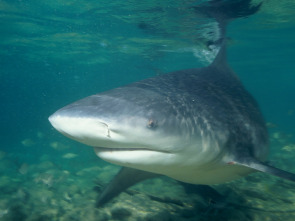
229;158;295;182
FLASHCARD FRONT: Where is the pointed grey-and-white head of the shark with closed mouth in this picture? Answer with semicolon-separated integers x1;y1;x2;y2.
49;84;215;176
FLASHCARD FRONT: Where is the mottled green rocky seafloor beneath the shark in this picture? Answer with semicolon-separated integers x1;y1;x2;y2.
0;127;295;221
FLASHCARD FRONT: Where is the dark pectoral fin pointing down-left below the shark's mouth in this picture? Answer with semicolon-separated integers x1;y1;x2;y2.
96;167;160;207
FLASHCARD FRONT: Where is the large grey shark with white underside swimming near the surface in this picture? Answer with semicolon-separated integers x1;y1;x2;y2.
49;0;295;206
